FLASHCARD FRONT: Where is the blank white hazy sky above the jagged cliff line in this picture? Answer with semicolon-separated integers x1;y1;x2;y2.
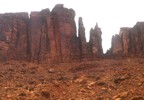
0;0;144;51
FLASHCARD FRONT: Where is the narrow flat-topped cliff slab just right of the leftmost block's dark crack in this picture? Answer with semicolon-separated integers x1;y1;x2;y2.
30;12;45;61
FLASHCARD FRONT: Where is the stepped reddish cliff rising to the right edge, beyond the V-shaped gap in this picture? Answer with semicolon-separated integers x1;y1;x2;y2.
111;22;144;54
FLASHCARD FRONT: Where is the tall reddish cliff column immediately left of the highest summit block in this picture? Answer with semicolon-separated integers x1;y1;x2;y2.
41;9;57;62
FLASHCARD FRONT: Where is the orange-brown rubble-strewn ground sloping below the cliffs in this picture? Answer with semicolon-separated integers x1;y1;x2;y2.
0;58;144;100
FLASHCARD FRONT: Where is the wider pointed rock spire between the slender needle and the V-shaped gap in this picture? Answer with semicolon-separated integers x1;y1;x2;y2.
89;24;103;55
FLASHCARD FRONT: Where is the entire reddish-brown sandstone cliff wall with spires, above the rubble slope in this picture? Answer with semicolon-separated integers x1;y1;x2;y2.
0;4;144;63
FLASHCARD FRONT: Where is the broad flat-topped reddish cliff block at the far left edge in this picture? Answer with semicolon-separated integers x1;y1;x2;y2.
0;13;30;60
